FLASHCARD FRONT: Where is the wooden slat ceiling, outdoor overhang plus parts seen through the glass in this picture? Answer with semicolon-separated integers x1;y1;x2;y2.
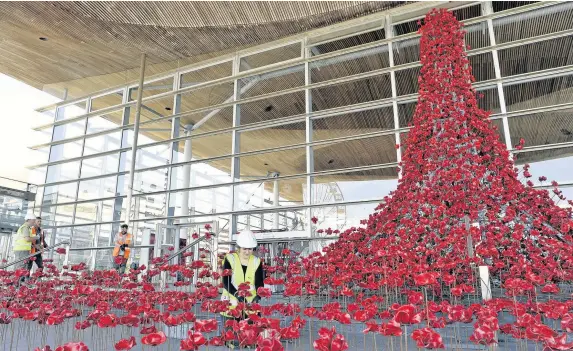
0;1;573;201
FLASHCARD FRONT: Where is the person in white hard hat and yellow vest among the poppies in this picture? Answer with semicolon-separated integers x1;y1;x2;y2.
221;230;264;348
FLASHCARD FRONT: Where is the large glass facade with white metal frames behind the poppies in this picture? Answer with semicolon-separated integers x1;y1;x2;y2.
30;2;573;262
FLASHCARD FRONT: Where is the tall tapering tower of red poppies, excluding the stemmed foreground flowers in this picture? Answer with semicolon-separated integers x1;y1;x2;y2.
306;11;573;292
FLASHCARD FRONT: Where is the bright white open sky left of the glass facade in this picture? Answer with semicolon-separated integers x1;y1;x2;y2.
0;74;60;185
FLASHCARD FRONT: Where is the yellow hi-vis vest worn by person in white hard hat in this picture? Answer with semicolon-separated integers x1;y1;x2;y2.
221;253;261;317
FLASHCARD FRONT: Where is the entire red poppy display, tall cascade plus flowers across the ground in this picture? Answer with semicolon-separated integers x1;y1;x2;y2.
0;10;573;351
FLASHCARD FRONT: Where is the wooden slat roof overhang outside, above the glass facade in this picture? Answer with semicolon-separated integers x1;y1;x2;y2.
0;1;403;91
